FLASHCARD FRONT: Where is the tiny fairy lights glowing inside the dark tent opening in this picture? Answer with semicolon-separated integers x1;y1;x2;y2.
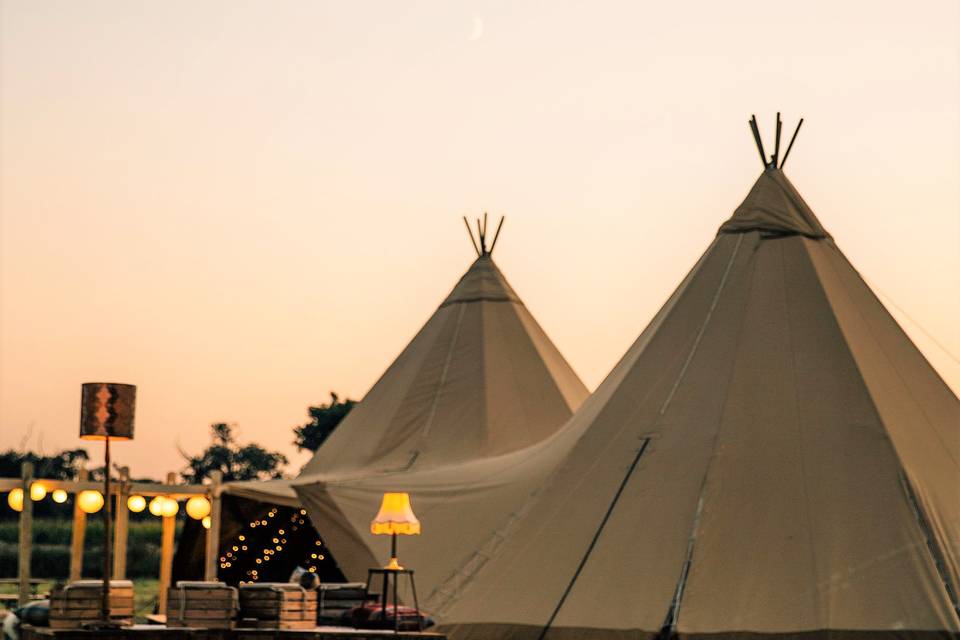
220;507;323;584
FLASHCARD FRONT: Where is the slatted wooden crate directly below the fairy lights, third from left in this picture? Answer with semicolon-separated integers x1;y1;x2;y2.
240;582;317;629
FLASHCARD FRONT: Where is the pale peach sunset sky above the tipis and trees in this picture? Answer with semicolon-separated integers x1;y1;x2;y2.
0;0;960;477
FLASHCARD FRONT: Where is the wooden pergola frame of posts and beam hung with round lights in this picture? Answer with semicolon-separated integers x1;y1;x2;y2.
0;462;223;614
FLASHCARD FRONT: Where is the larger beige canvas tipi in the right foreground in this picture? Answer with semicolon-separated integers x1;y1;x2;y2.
440;125;960;640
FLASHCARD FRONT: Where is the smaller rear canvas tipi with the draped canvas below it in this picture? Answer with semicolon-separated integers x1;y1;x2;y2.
292;218;588;594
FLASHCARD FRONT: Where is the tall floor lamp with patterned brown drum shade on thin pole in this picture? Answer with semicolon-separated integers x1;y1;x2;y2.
80;382;137;625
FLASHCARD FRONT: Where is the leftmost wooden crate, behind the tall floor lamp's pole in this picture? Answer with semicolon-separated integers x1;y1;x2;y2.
50;580;133;629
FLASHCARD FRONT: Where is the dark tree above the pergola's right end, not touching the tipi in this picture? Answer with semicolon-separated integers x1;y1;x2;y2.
180;422;287;484
